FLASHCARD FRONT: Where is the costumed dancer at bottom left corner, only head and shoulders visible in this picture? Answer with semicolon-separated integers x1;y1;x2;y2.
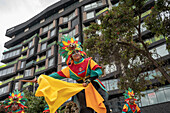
4;90;27;113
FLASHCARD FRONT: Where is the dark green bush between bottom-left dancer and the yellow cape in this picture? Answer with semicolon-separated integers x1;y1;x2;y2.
24;90;46;113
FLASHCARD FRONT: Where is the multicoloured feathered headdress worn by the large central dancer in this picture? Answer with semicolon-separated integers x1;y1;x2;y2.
59;35;86;65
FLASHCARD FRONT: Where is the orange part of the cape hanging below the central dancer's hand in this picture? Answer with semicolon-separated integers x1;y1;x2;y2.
85;83;106;113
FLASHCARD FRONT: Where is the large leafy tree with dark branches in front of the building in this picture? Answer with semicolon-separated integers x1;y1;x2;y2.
83;0;170;96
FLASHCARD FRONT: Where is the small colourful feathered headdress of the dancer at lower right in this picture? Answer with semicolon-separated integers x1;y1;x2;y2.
123;88;136;102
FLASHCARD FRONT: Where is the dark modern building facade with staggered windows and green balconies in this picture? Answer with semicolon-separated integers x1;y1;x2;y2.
0;0;170;113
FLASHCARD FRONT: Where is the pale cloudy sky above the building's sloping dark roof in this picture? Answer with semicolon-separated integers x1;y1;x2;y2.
0;0;60;65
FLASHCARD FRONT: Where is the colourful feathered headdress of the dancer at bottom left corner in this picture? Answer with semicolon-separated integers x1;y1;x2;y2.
4;90;27;110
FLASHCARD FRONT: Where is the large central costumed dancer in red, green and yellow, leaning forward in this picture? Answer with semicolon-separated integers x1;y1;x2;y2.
30;36;110;113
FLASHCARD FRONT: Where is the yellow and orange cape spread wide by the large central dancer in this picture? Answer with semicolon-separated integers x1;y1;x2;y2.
35;75;106;113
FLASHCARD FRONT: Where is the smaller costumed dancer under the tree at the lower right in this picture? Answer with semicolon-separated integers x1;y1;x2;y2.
122;88;141;113
